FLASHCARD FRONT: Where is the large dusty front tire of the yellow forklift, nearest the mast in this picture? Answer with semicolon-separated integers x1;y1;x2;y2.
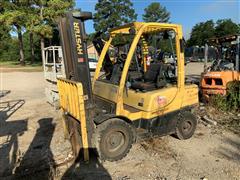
94;118;135;161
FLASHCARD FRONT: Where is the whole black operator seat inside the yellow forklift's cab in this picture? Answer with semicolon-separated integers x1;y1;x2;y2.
131;63;166;91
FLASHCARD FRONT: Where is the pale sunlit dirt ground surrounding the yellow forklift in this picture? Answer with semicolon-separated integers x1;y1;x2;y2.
0;63;240;180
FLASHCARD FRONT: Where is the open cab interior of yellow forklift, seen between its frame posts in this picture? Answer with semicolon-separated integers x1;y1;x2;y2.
98;26;177;92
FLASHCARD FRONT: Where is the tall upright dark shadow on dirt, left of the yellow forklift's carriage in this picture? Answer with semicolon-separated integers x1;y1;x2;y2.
14;118;55;179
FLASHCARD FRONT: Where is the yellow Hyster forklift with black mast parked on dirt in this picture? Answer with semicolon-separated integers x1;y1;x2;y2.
57;11;198;161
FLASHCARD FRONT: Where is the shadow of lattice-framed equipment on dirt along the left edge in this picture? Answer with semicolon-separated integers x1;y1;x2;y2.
0;99;27;178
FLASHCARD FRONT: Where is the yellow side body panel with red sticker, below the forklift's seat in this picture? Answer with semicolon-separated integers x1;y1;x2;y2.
120;85;198;121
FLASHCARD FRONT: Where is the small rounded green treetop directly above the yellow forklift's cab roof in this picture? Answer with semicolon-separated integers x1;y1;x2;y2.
143;2;170;22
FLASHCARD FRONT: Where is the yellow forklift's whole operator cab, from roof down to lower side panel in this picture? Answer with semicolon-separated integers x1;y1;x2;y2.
93;22;190;120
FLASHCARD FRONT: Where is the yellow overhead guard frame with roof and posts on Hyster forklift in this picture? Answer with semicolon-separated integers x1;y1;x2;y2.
93;22;185;114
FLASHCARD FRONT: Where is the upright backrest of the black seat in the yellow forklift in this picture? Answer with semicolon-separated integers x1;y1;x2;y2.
144;63;161;82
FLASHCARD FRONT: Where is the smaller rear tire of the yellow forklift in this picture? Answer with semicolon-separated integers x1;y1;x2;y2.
176;111;197;140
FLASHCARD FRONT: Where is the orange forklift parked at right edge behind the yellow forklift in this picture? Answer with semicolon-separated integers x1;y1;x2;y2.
201;34;240;101
